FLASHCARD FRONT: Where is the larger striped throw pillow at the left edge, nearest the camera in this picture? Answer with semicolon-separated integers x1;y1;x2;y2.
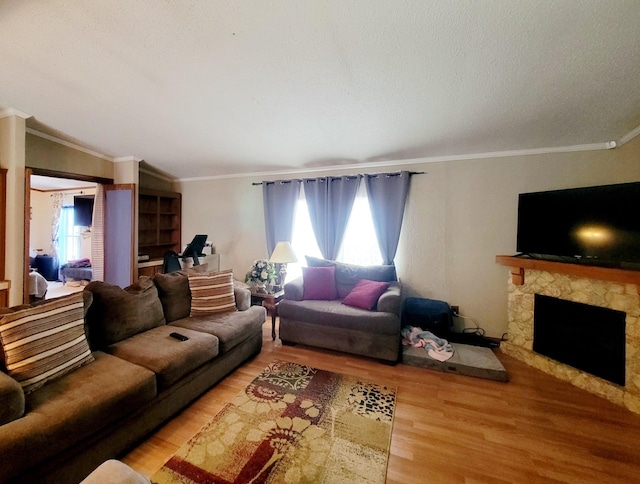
0;292;93;393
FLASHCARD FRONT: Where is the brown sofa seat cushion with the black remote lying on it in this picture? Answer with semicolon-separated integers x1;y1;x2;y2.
107;326;218;389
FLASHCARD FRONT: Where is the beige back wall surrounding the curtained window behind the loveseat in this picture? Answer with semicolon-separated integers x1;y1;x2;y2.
178;137;640;337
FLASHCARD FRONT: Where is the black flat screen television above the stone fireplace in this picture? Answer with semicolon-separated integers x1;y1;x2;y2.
517;182;640;268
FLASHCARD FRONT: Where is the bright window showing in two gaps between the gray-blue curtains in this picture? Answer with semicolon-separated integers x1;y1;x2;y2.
286;183;382;281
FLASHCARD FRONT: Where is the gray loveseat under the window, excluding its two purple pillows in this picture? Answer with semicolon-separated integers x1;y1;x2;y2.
278;257;402;363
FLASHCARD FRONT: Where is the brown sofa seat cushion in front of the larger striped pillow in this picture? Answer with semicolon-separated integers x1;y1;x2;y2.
0;351;156;480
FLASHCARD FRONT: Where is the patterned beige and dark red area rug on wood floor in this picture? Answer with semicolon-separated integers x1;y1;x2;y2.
151;361;396;484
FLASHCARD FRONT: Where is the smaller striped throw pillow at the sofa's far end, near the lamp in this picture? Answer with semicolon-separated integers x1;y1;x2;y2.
189;270;236;316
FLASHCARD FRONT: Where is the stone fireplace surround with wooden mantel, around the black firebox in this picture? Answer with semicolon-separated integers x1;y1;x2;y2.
496;256;640;413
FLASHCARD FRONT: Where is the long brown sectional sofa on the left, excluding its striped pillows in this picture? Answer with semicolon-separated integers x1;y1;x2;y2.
0;270;266;483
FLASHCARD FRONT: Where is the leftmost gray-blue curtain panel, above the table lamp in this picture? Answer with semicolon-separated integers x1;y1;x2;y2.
262;180;300;256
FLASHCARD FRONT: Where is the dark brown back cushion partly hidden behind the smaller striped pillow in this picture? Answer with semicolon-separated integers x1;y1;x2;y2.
153;264;208;323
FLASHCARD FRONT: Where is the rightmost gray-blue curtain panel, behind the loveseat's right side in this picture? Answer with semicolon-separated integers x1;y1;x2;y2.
364;171;411;264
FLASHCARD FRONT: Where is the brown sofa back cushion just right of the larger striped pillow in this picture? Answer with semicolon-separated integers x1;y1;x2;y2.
85;276;166;349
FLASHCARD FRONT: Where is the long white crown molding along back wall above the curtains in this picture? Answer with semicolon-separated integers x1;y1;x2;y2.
176;141;619;183
